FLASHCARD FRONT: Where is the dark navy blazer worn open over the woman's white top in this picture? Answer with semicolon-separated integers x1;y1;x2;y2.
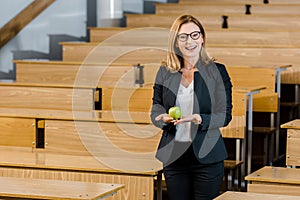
151;62;232;165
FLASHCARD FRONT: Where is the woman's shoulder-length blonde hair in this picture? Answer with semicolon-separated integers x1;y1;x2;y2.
162;15;212;72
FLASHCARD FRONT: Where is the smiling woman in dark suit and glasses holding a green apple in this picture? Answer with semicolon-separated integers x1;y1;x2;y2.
151;15;232;200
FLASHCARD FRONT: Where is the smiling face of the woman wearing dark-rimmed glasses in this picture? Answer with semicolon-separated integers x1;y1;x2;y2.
176;22;203;59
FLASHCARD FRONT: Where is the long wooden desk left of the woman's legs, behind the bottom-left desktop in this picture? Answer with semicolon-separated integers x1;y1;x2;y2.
0;146;162;200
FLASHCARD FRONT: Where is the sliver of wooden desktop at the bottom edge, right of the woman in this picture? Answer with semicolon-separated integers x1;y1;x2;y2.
215;191;299;200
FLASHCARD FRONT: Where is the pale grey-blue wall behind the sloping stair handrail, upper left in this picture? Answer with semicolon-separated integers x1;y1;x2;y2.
0;0;171;79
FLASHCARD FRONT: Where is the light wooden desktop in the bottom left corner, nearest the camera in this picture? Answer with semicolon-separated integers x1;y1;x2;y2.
0;177;124;200
